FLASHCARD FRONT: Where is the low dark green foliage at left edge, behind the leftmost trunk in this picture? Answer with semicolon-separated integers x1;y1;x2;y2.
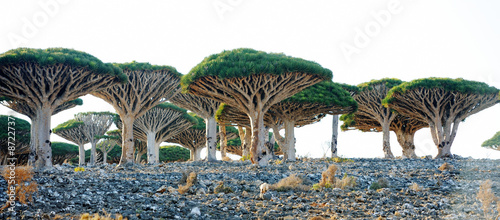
0;115;31;144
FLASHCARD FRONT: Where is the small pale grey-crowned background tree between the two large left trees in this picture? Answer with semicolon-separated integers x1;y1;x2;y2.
75;112;115;166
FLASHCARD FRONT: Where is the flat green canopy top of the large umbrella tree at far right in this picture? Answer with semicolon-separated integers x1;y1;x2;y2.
382;77;500;106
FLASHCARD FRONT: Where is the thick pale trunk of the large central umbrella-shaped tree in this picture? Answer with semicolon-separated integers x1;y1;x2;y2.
250;112;269;166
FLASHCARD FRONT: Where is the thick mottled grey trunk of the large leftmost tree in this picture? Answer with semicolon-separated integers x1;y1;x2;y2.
35;106;52;168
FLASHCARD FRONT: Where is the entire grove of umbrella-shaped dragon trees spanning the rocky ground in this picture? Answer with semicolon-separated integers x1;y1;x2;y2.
0;48;499;167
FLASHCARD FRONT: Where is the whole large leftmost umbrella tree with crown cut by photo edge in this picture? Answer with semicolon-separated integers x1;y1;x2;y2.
0;48;127;168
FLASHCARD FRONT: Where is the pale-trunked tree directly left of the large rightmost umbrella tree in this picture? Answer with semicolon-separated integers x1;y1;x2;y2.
353;78;402;158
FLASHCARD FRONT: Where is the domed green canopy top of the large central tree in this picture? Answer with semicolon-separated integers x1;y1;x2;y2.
181;48;332;88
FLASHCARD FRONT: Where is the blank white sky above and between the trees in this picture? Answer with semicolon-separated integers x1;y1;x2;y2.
0;0;500;158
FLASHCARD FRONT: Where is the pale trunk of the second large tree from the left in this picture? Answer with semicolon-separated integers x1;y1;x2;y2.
118;115;137;166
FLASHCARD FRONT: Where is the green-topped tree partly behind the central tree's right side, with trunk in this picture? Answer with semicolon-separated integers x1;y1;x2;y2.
268;80;357;161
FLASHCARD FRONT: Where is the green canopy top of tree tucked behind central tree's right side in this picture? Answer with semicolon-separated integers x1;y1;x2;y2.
281;80;358;108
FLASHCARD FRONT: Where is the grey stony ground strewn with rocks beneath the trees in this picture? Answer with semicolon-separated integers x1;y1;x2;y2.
0;158;500;219
